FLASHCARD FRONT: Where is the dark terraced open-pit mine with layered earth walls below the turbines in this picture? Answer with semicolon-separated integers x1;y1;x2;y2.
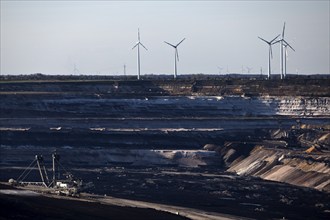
0;76;330;219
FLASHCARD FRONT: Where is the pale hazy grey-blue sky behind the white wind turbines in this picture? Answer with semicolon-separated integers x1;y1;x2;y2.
1;0;330;74
